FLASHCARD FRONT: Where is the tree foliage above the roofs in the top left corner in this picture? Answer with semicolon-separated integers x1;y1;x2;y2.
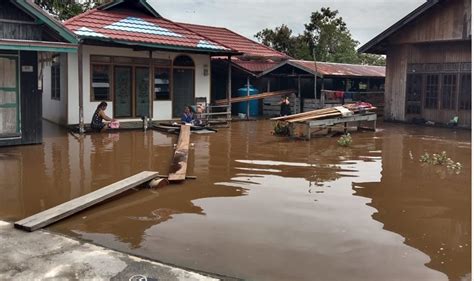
35;0;109;21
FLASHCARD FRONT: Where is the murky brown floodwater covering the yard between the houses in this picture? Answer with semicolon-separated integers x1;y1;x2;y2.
0;121;471;281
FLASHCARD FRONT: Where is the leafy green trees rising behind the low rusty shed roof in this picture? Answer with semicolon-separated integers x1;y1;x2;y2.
255;8;385;65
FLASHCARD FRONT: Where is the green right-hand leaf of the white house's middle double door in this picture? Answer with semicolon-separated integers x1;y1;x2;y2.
135;67;150;117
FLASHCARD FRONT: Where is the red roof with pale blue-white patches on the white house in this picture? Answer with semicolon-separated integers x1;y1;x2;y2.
65;9;234;53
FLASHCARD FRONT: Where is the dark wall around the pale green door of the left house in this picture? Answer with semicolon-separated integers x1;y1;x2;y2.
0;51;43;146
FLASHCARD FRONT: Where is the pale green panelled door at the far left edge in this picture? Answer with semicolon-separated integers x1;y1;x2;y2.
0;56;20;137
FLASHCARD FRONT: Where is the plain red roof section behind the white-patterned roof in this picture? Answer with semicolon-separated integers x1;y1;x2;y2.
179;23;290;59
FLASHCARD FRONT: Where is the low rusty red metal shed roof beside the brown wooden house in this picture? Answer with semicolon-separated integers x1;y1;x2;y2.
287;60;385;77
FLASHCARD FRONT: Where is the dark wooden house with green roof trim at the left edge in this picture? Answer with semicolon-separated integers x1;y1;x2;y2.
0;0;77;146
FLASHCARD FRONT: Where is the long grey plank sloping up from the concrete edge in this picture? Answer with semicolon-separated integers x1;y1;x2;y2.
14;171;159;231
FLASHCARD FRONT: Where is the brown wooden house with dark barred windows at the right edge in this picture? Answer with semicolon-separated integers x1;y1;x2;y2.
359;0;472;128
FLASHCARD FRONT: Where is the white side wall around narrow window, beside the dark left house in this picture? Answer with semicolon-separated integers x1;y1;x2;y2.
42;54;68;125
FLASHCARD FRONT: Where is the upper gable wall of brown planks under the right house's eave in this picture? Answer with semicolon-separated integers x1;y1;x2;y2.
389;0;471;44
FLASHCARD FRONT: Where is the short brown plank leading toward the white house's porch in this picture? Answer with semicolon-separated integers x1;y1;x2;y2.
168;125;191;182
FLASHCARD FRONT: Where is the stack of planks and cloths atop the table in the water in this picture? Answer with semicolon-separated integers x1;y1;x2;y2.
270;104;377;123
